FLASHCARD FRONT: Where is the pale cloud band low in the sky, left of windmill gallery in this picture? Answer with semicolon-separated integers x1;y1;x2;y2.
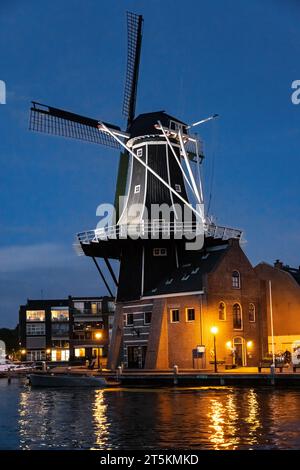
0;243;77;273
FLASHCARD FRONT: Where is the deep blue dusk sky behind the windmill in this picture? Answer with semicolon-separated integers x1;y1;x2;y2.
0;0;300;326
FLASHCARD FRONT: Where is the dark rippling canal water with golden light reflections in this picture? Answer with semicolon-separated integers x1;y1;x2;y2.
0;379;300;450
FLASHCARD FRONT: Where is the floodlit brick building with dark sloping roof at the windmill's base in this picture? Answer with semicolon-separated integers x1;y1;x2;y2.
109;239;267;369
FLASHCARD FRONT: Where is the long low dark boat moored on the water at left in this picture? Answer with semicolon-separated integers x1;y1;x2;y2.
28;374;107;388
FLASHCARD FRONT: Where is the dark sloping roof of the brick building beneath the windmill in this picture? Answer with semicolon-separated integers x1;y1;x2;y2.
143;245;228;297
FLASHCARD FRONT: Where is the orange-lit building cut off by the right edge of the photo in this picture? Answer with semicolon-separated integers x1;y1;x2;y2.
255;260;300;353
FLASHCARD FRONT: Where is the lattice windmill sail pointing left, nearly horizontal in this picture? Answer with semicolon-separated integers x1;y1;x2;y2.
29;101;120;148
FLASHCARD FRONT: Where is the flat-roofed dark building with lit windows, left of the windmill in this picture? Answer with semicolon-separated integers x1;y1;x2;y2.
19;296;114;365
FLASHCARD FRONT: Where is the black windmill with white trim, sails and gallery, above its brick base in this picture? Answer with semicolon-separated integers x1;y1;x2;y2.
30;13;241;301
